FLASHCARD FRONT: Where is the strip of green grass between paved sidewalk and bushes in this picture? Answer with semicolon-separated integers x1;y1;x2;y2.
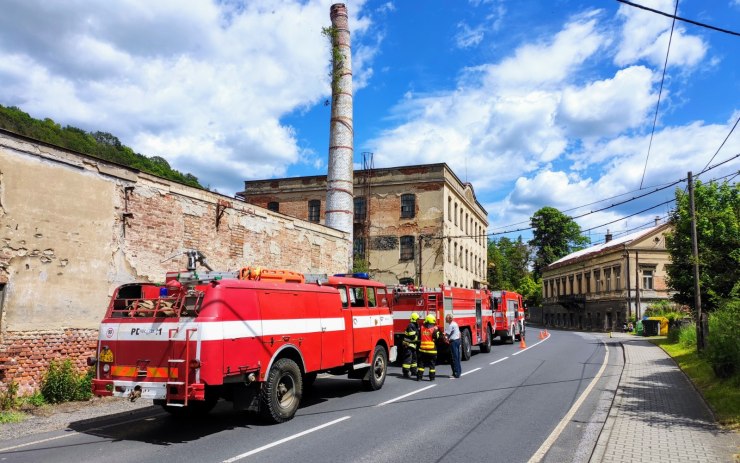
650;338;740;431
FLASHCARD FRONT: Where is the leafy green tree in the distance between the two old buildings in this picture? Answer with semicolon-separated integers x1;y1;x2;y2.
529;206;589;280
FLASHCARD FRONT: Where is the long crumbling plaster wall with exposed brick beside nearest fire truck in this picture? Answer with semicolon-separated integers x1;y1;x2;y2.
0;131;351;392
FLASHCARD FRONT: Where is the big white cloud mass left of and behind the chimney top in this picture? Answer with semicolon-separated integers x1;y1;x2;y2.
0;0;376;193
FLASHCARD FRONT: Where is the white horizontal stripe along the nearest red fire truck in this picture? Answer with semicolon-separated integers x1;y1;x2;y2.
98;315;393;341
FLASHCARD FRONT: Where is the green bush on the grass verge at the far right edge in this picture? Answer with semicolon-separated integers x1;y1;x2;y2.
705;299;740;378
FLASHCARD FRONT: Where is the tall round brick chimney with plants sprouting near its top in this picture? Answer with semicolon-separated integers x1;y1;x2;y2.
325;3;354;268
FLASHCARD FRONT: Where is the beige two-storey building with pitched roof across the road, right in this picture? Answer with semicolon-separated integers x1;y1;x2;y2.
542;223;671;331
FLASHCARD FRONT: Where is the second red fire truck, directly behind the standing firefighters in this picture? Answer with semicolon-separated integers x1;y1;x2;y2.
393;285;493;360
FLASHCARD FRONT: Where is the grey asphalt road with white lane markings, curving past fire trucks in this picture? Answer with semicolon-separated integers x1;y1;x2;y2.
0;329;623;463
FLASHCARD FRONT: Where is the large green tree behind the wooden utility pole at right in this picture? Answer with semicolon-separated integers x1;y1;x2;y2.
666;181;740;315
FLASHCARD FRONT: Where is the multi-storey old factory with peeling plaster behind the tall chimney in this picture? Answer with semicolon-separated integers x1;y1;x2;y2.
237;163;488;288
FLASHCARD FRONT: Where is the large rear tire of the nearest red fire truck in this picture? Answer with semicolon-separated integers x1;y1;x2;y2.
260;358;303;423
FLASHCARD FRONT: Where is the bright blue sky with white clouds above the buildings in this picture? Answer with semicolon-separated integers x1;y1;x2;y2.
0;0;740;242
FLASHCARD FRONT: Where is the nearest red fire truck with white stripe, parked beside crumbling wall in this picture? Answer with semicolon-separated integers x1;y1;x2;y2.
89;251;396;422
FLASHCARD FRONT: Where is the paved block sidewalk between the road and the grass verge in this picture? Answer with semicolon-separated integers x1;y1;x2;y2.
591;333;740;463
